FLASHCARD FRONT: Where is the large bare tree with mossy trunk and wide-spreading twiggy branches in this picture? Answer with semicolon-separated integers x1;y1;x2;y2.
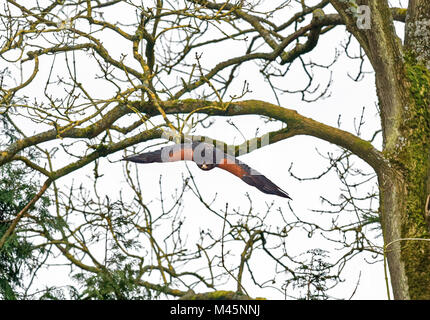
0;0;430;299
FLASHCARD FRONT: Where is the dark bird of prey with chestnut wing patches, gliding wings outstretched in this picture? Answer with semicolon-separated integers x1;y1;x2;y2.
122;141;291;199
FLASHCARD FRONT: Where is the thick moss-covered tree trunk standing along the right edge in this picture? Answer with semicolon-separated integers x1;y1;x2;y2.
371;0;430;299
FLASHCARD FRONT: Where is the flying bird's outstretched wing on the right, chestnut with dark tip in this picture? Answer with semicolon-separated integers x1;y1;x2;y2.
217;154;291;199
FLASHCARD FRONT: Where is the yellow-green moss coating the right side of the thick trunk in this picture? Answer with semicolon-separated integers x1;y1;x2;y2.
392;53;430;299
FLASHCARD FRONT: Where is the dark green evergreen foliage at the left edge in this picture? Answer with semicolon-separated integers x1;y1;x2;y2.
0;118;49;300
